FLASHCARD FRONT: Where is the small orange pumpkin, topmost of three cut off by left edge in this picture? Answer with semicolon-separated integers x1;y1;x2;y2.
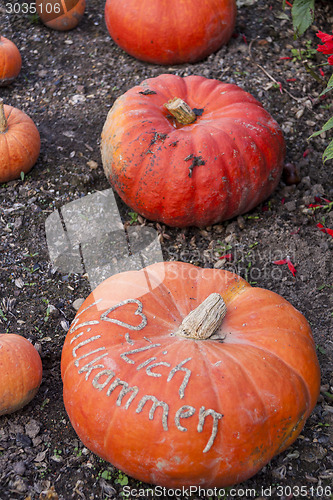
0;35;22;87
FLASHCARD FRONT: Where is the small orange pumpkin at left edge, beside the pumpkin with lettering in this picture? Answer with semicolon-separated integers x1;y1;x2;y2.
0;333;43;415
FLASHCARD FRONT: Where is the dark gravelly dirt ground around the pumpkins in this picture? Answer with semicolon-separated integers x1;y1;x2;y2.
0;0;333;500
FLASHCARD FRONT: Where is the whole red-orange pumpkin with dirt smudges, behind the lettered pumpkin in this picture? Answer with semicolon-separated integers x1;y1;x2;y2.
101;74;285;227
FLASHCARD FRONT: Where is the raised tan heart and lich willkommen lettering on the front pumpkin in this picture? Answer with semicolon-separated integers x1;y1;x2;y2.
70;299;223;453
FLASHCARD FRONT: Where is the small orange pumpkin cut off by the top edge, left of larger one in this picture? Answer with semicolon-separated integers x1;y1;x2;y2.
36;0;86;31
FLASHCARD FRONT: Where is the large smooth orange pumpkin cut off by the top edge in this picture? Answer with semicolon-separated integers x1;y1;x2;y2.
105;0;237;64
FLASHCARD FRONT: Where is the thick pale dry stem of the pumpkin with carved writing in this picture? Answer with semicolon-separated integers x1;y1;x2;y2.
174;293;227;340
